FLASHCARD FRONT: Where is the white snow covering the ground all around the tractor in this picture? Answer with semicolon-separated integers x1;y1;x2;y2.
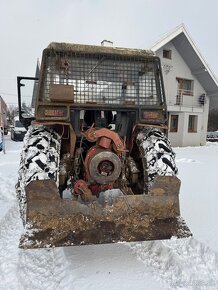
0;136;218;290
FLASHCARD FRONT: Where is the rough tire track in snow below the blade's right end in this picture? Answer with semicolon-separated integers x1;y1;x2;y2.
129;237;218;290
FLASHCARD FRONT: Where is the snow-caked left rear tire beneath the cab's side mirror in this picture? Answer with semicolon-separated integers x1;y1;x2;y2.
16;126;60;224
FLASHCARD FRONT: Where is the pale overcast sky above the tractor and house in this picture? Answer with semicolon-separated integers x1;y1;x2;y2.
0;0;218;104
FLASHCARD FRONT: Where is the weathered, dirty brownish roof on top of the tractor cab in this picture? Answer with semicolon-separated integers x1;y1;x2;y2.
46;42;155;57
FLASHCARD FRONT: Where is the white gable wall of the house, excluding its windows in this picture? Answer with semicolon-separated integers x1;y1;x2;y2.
156;42;209;146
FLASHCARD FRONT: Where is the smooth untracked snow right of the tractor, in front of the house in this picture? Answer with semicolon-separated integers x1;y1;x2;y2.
175;143;218;253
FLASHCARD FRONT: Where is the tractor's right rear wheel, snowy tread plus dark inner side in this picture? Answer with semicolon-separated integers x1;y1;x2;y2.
131;128;178;194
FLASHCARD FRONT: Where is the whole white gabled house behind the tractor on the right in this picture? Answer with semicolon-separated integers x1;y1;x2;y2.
151;25;218;146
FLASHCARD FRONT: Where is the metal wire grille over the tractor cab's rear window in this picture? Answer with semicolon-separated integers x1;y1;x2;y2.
41;53;159;105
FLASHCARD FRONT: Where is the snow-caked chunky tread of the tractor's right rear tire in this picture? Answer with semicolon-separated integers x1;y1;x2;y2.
136;128;178;191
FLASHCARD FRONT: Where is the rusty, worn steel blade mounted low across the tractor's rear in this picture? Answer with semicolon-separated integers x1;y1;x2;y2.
20;176;191;248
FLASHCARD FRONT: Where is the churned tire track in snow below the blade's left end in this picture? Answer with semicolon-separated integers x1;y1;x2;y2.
18;248;73;290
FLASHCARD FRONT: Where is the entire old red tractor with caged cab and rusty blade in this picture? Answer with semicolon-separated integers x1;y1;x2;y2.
16;43;191;248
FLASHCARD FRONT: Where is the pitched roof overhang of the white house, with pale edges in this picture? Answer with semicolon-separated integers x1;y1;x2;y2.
151;24;218;96
